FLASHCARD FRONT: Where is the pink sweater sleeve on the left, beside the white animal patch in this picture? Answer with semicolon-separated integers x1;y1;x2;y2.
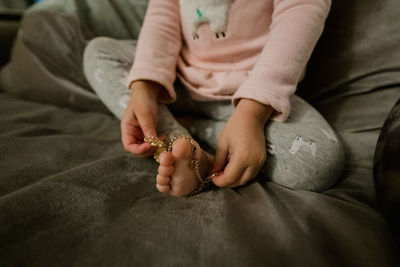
128;0;182;103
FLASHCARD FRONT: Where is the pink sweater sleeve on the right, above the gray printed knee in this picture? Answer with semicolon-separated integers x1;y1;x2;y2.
233;0;331;121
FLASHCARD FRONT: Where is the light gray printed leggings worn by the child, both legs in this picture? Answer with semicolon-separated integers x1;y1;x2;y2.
84;37;344;191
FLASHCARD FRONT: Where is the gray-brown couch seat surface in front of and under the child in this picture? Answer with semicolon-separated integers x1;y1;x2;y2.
0;91;399;267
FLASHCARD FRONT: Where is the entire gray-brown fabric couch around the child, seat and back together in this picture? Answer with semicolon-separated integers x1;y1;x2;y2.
0;0;400;267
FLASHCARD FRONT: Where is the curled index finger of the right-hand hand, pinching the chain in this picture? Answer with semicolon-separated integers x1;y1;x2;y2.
212;157;246;187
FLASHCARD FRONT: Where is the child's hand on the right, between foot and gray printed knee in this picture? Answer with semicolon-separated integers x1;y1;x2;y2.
212;99;273;187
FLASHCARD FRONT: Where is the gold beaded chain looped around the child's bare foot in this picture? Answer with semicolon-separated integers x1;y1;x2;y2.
144;135;216;198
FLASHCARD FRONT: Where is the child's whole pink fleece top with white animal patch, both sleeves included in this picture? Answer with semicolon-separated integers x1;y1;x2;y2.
128;0;331;121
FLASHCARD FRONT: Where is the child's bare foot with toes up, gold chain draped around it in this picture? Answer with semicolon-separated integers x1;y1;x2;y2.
156;138;211;197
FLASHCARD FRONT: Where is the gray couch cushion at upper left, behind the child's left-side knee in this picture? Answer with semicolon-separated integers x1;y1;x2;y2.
0;0;147;112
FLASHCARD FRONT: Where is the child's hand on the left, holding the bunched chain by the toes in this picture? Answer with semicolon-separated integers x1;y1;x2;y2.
121;81;163;156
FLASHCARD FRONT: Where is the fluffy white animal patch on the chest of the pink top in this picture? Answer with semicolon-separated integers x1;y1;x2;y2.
179;0;234;39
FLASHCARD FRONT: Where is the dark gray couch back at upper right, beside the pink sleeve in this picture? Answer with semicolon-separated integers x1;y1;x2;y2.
297;0;400;101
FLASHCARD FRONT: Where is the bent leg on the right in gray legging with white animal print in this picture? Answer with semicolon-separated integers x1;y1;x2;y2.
263;95;345;191
